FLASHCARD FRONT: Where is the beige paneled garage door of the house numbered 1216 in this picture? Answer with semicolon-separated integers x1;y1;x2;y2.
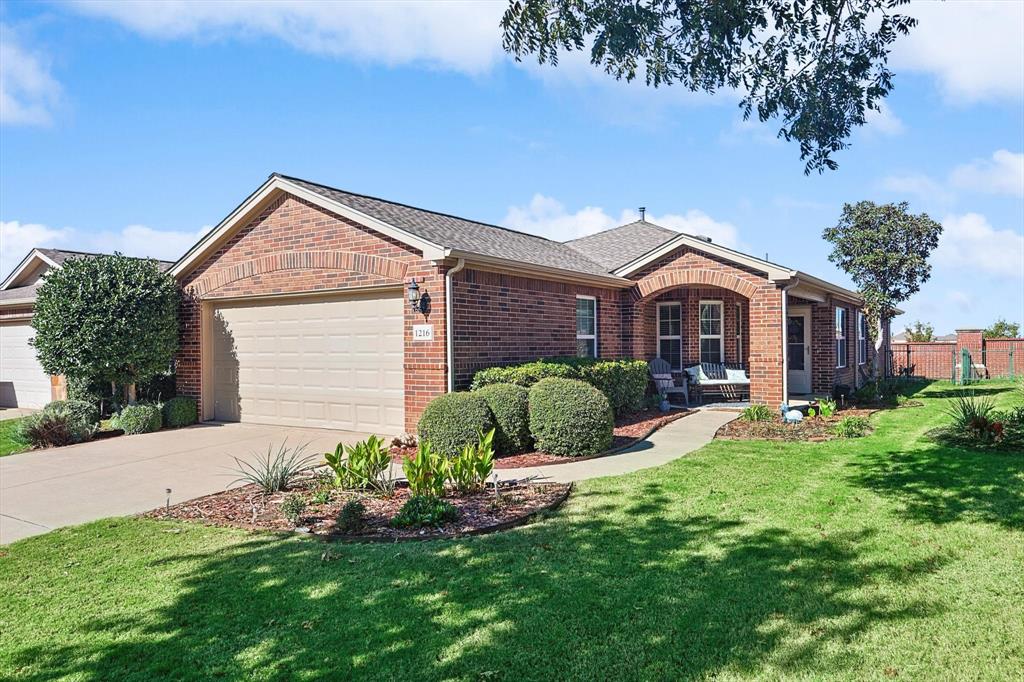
212;291;404;434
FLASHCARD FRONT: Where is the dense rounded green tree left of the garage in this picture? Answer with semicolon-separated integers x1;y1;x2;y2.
31;254;180;401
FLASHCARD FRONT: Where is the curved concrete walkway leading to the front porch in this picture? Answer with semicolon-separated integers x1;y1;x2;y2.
495;410;739;483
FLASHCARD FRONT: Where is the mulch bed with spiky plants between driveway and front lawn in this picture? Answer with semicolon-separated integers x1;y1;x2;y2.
143;476;571;542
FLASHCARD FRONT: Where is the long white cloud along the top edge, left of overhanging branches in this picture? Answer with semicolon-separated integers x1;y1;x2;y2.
71;0;505;74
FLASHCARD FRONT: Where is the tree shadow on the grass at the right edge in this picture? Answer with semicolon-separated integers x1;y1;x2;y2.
850;443;1024;529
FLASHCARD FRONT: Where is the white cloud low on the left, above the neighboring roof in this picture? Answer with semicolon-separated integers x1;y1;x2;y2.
0;220;210;276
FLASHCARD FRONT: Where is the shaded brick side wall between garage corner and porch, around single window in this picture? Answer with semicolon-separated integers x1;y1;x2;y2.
453;268;624;387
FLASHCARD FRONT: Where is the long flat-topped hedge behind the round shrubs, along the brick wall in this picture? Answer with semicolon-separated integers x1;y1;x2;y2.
472;357;650;414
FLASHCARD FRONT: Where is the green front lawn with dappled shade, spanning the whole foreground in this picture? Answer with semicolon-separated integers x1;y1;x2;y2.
0;378;1024;680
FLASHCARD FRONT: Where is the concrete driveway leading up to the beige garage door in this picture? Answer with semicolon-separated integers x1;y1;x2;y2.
0;422;369;545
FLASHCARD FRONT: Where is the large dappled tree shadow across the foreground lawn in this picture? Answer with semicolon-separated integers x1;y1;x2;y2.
12;483;944;680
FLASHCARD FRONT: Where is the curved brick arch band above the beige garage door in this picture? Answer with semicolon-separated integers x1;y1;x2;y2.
189;251;409;296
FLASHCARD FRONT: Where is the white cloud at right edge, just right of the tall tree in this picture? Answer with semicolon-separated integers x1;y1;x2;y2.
935;213;1024;280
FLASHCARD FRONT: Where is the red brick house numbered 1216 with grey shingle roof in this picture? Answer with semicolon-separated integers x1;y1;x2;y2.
171;174;888;433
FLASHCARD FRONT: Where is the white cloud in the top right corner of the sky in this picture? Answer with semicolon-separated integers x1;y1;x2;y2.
892;0;1024;103
